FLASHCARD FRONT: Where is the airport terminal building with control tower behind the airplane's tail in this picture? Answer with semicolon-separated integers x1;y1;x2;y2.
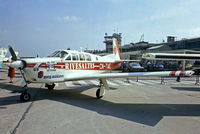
103;33;200;60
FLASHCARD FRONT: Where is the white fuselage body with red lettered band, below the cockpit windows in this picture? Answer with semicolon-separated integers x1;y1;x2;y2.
22;53;121;83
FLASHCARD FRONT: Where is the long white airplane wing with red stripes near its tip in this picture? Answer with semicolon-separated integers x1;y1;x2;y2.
66;71;194;81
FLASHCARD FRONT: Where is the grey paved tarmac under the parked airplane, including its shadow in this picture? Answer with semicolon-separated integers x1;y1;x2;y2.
0;70;200;134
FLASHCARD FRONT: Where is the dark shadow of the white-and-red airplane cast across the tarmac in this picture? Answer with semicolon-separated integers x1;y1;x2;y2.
0;83;200;126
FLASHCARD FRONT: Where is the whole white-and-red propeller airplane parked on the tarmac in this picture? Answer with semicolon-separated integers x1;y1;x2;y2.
8;38;193;101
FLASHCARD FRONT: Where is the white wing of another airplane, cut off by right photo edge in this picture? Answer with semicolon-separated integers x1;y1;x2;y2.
142;53;200;61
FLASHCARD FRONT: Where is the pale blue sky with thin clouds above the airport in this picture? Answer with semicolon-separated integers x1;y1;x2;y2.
0;0;200;56
